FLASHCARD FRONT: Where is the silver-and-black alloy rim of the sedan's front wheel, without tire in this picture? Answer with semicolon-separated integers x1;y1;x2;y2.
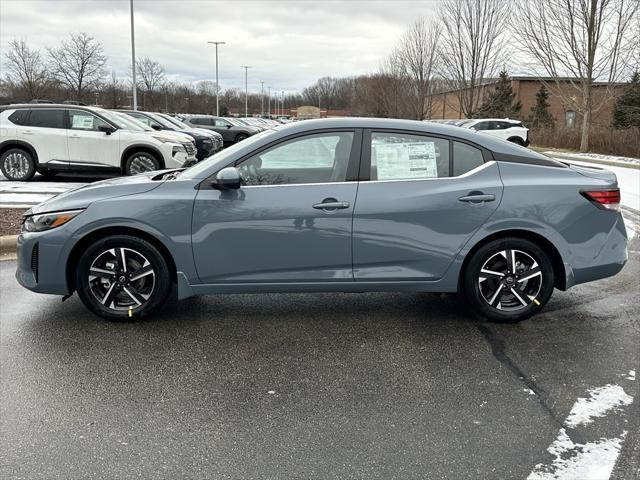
89;248;156;310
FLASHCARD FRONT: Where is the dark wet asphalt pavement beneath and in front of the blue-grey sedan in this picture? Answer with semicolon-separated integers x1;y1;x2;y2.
0;223;640;480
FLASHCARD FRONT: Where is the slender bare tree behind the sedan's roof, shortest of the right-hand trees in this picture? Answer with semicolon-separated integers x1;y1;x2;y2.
392;19;440;120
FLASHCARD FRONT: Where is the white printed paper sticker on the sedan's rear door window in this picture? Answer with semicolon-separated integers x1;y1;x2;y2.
372;142;438;180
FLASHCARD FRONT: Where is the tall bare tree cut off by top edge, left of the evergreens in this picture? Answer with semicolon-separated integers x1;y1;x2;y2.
441;0;509;118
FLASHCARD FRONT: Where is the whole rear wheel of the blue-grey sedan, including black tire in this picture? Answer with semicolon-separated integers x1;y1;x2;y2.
462;237;554;323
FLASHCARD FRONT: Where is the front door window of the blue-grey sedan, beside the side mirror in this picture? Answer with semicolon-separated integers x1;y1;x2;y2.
237;132;353;185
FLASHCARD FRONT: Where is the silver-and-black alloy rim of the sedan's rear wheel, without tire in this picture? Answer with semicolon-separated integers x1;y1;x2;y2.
478;249;543;312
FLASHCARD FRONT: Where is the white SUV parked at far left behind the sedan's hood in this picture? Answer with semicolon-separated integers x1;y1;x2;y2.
0;104;196;181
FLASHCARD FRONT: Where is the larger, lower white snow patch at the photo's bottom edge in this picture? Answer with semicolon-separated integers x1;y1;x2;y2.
527;428;627;480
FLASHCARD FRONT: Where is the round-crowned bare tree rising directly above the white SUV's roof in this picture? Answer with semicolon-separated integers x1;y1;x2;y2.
47;32;107;101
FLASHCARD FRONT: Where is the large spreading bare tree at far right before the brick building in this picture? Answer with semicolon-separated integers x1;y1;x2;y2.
513;0;640;152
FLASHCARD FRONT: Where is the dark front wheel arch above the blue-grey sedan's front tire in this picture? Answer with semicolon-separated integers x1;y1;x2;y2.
65;226;178;292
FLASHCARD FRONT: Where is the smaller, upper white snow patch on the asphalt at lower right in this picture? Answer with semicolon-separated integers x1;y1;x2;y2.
564;385;633;428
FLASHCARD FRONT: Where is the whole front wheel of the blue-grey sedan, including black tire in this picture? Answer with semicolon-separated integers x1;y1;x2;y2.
75;235;171;322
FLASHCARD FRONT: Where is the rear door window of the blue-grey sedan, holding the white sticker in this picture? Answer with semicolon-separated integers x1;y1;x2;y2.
371;132;449;180
